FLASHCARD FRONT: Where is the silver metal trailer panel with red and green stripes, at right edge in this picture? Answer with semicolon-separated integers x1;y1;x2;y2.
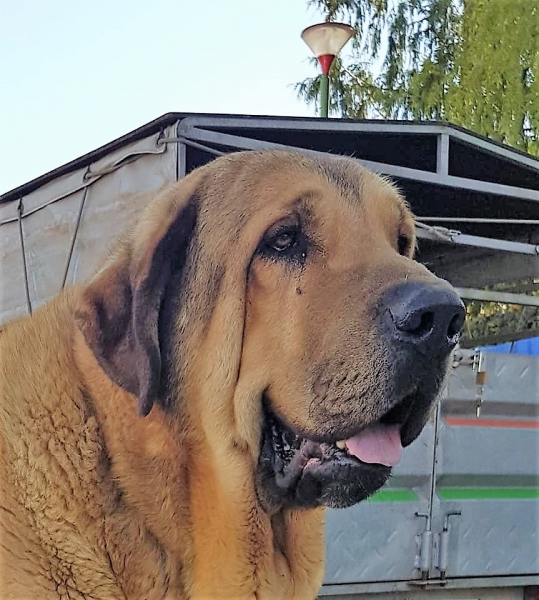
431;353;539;577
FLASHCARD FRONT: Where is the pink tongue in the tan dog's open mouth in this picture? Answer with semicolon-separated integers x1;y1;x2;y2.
345;425;402;467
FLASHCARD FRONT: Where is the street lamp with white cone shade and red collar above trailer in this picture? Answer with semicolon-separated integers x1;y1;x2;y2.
301;22;354;118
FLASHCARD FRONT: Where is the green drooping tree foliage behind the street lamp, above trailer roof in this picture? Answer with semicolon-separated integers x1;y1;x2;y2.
297;0;539;154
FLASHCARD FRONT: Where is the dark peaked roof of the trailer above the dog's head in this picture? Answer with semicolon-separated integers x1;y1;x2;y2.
0;113;539;204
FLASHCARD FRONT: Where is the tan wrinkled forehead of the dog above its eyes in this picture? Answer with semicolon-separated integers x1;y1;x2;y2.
192;150;409;255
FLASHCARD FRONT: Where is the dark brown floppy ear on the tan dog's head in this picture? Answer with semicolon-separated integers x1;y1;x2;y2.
76;186;198;416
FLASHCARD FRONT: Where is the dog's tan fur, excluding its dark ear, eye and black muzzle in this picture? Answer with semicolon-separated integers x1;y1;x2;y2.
0;153;442;600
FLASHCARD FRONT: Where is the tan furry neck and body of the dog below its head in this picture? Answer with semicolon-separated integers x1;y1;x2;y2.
0;295;323;600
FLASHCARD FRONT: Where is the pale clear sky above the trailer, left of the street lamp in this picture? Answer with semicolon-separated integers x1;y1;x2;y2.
0;0;332;194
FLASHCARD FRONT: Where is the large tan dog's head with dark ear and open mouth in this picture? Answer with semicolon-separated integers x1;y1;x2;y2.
77;152;464;510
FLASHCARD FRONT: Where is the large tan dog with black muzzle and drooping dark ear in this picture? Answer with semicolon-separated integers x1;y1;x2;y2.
0;151;464;600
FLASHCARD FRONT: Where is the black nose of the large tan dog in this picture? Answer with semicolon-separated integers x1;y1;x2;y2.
384;281;466;355
